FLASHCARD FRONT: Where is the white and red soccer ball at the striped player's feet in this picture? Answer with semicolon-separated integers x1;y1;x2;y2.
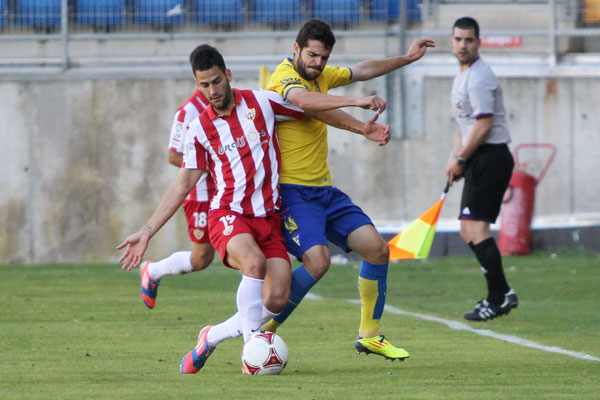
242;332;288;375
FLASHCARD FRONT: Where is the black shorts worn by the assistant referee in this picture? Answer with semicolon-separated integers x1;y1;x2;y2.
458;144;515;223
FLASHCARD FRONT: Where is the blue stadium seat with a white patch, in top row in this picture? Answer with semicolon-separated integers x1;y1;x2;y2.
133;0;184;25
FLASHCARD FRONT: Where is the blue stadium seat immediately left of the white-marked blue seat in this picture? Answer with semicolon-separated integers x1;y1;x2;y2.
75;0;125;26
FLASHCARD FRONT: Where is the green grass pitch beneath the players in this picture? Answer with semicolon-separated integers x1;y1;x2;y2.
0;252;600;400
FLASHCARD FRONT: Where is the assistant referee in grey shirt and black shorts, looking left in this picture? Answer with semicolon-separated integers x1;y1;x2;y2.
445;17;519;321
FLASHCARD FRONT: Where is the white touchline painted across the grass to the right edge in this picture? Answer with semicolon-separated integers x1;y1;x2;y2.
348;299;600;361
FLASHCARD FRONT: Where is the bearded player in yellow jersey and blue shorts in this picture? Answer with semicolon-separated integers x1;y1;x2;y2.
263;19;434;360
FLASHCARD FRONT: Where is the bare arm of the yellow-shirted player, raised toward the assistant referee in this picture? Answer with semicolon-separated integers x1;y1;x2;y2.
351;39;435;82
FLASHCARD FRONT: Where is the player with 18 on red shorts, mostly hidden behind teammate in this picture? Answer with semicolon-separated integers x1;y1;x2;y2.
135;89;215;309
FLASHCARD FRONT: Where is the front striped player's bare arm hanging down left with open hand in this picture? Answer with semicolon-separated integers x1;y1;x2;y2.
117;168;204;271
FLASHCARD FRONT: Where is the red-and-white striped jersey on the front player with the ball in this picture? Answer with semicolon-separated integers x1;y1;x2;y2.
183;89;304;217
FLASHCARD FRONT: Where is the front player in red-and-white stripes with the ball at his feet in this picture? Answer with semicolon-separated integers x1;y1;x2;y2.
117;45;389;374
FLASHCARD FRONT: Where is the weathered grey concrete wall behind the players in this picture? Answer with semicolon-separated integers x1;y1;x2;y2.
0;65;600;263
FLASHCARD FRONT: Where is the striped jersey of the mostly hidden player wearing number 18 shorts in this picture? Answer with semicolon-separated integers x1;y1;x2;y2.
169;89;215;202
